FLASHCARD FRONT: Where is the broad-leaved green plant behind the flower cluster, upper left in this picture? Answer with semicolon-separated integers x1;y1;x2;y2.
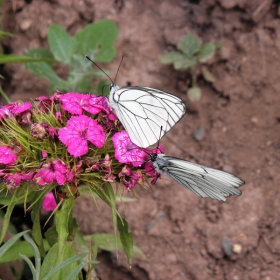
0;20;118;93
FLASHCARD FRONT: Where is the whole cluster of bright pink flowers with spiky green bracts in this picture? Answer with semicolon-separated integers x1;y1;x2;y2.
0;91;162;210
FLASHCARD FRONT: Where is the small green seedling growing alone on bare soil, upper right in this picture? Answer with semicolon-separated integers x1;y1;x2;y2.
160;34;221;102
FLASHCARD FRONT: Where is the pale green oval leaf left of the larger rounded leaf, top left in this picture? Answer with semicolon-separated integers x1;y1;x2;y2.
48;24;77;64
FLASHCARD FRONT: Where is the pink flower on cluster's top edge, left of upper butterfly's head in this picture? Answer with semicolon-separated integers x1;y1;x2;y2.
60;92;101;115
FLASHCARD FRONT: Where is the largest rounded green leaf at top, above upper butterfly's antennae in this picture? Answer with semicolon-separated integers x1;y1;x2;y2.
75;19;118;62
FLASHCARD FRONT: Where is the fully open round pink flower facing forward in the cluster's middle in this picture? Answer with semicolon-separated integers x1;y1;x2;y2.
58;115;106;157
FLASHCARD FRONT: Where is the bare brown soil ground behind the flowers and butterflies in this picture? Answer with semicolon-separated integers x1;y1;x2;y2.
3;0;280;280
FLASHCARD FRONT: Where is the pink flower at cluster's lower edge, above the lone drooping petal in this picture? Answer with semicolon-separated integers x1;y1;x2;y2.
34;159;73;186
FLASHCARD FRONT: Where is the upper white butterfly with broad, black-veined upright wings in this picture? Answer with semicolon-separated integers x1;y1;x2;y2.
109;87;186;148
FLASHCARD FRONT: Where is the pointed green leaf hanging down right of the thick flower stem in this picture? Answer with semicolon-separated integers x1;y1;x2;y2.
117;216;133;265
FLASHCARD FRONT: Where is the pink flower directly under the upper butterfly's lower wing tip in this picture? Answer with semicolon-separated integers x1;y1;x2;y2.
112;131;146;167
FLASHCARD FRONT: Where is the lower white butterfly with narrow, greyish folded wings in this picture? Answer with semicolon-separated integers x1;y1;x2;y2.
150;153;245;201
